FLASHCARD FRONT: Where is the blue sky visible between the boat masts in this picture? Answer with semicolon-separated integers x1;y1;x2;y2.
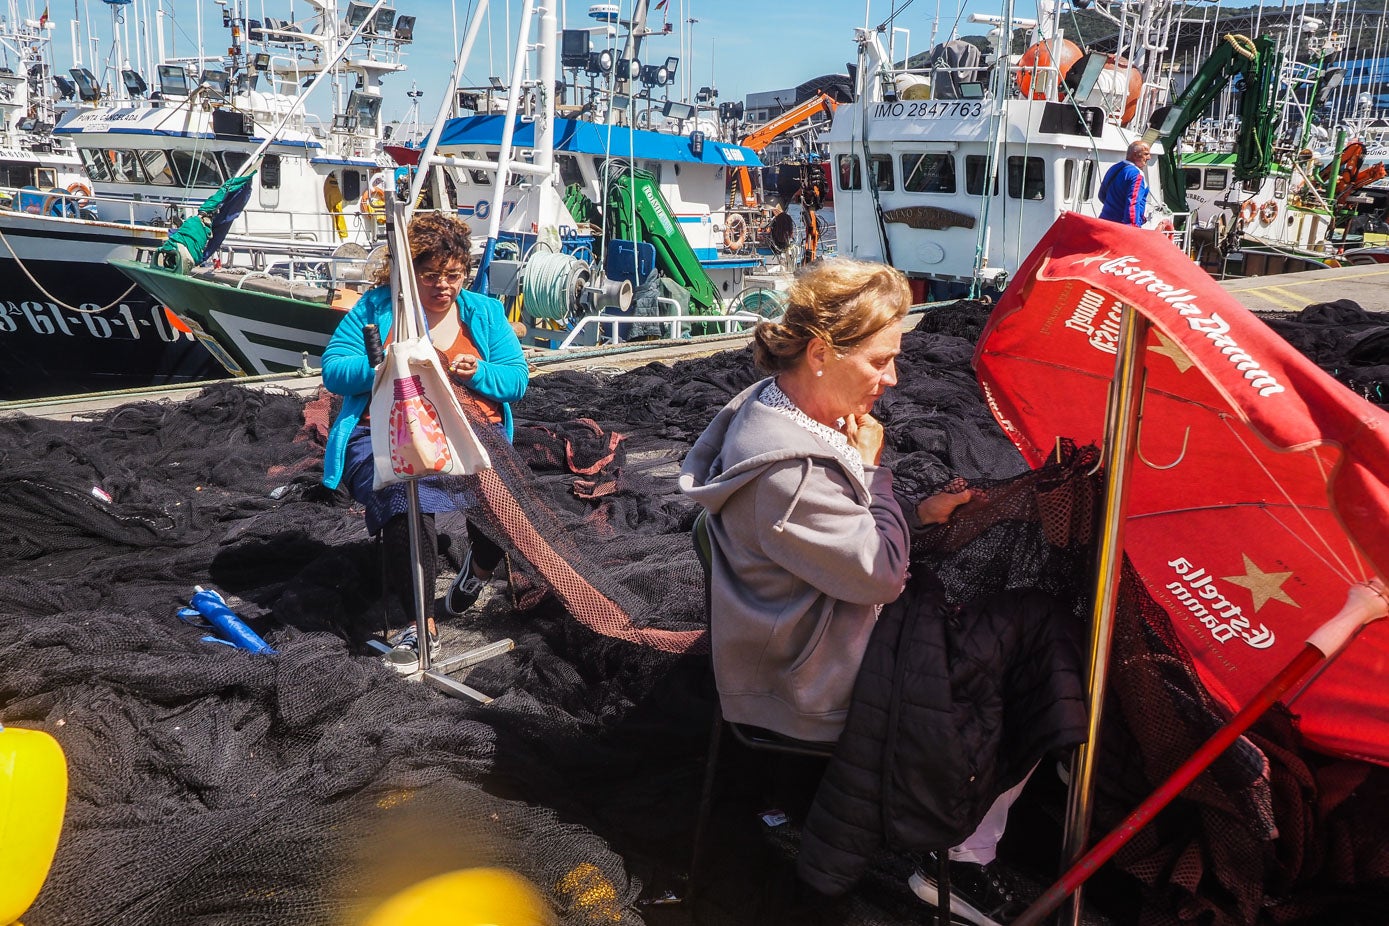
67;0;1011;121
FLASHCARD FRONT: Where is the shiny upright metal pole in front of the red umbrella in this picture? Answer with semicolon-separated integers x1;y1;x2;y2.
1051;305;1149;926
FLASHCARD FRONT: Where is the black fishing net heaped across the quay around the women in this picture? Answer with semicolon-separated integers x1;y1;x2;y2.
0;304;1389;926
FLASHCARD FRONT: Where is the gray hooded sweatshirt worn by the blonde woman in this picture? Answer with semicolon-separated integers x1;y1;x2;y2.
679;379;910;741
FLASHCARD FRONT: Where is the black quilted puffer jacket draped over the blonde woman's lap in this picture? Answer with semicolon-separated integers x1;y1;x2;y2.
797;572;1086;895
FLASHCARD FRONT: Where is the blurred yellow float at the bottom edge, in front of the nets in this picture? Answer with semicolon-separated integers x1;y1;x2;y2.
363;868;554;926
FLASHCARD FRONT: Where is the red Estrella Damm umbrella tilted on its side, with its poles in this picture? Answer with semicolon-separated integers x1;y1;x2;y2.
975;214;1389;922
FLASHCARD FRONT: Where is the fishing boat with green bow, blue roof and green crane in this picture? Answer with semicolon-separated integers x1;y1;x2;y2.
114;0;789;373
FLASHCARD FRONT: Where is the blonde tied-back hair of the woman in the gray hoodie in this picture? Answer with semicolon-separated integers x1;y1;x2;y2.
753;258;911;373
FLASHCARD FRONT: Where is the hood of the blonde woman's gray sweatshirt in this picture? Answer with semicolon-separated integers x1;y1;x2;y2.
679;379;872;521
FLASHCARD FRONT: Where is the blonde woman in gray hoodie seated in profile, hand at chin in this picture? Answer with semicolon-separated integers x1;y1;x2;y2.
679;260;1088;926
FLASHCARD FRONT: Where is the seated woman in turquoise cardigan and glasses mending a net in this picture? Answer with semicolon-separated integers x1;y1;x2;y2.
324;212;529;673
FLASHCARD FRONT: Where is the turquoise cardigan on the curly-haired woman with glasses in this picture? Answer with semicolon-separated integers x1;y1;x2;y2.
324;286;531;489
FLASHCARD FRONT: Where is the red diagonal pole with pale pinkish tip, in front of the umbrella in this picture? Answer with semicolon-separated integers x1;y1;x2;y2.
1013;579;1389;926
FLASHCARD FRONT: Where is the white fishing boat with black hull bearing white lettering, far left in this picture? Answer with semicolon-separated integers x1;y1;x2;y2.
0;0;414;398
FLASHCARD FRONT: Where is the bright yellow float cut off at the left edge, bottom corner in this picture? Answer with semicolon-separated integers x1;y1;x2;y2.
0;726;68;923
